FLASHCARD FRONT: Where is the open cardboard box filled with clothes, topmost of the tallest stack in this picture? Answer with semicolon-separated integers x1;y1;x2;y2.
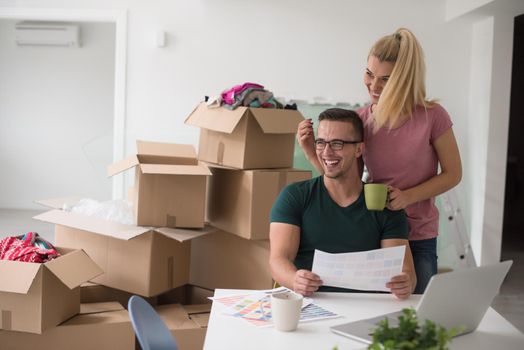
185;103;304;169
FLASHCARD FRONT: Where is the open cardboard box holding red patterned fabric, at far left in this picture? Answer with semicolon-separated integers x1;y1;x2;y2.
0;247;102;334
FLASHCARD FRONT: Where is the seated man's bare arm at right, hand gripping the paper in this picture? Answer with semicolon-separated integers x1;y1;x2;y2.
380;239;417;299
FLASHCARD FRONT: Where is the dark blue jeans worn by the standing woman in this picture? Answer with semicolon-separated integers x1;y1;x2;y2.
409;237;437;294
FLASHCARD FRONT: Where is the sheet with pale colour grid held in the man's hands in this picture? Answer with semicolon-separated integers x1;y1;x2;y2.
312;246;406;292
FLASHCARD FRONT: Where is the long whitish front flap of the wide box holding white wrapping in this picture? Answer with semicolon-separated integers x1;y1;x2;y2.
33;209;151;240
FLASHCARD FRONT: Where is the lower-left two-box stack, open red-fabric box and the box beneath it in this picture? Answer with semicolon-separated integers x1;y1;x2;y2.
0;247;135;350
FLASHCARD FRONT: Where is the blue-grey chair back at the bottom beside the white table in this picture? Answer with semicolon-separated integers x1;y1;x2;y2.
127;295;178;350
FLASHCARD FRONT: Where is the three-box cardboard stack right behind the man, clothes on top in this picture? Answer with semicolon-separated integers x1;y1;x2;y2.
186;103;311;289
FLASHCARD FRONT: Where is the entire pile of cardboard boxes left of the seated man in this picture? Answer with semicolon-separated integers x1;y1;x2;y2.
0;100;311;350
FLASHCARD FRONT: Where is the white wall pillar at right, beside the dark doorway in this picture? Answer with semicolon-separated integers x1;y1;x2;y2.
447;0;524;264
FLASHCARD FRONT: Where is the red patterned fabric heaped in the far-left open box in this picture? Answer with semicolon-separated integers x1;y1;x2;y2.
0;232;59;263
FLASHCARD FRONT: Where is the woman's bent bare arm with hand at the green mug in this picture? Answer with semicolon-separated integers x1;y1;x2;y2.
388;128;462;210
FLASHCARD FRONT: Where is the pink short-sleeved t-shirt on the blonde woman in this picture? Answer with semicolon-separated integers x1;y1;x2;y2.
358;104;453;240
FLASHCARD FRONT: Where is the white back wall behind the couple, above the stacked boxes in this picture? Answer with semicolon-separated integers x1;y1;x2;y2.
93;0;470;197
